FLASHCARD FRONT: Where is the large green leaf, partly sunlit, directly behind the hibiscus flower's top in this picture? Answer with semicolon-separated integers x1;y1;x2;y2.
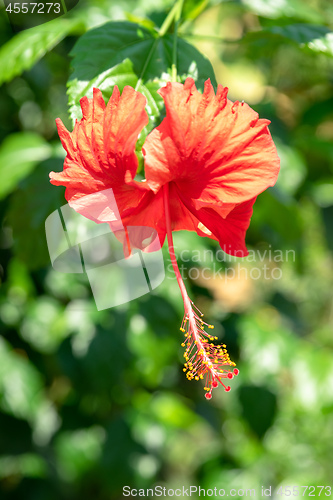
68;22;216;140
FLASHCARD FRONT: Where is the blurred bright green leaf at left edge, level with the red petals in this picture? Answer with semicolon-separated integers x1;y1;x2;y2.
0;132;52;199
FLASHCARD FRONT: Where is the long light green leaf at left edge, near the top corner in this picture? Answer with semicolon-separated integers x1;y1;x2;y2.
0;19;82;85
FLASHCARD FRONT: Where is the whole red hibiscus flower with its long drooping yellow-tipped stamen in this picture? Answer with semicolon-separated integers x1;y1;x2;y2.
50;78;279;398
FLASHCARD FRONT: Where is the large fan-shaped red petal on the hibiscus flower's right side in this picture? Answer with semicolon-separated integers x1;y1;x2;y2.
144;78;279;205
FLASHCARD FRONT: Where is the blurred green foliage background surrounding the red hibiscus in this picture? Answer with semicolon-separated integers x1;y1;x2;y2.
0;0;333;500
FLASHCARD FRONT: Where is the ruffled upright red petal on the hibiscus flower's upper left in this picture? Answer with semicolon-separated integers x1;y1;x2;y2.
50;87;148;204
